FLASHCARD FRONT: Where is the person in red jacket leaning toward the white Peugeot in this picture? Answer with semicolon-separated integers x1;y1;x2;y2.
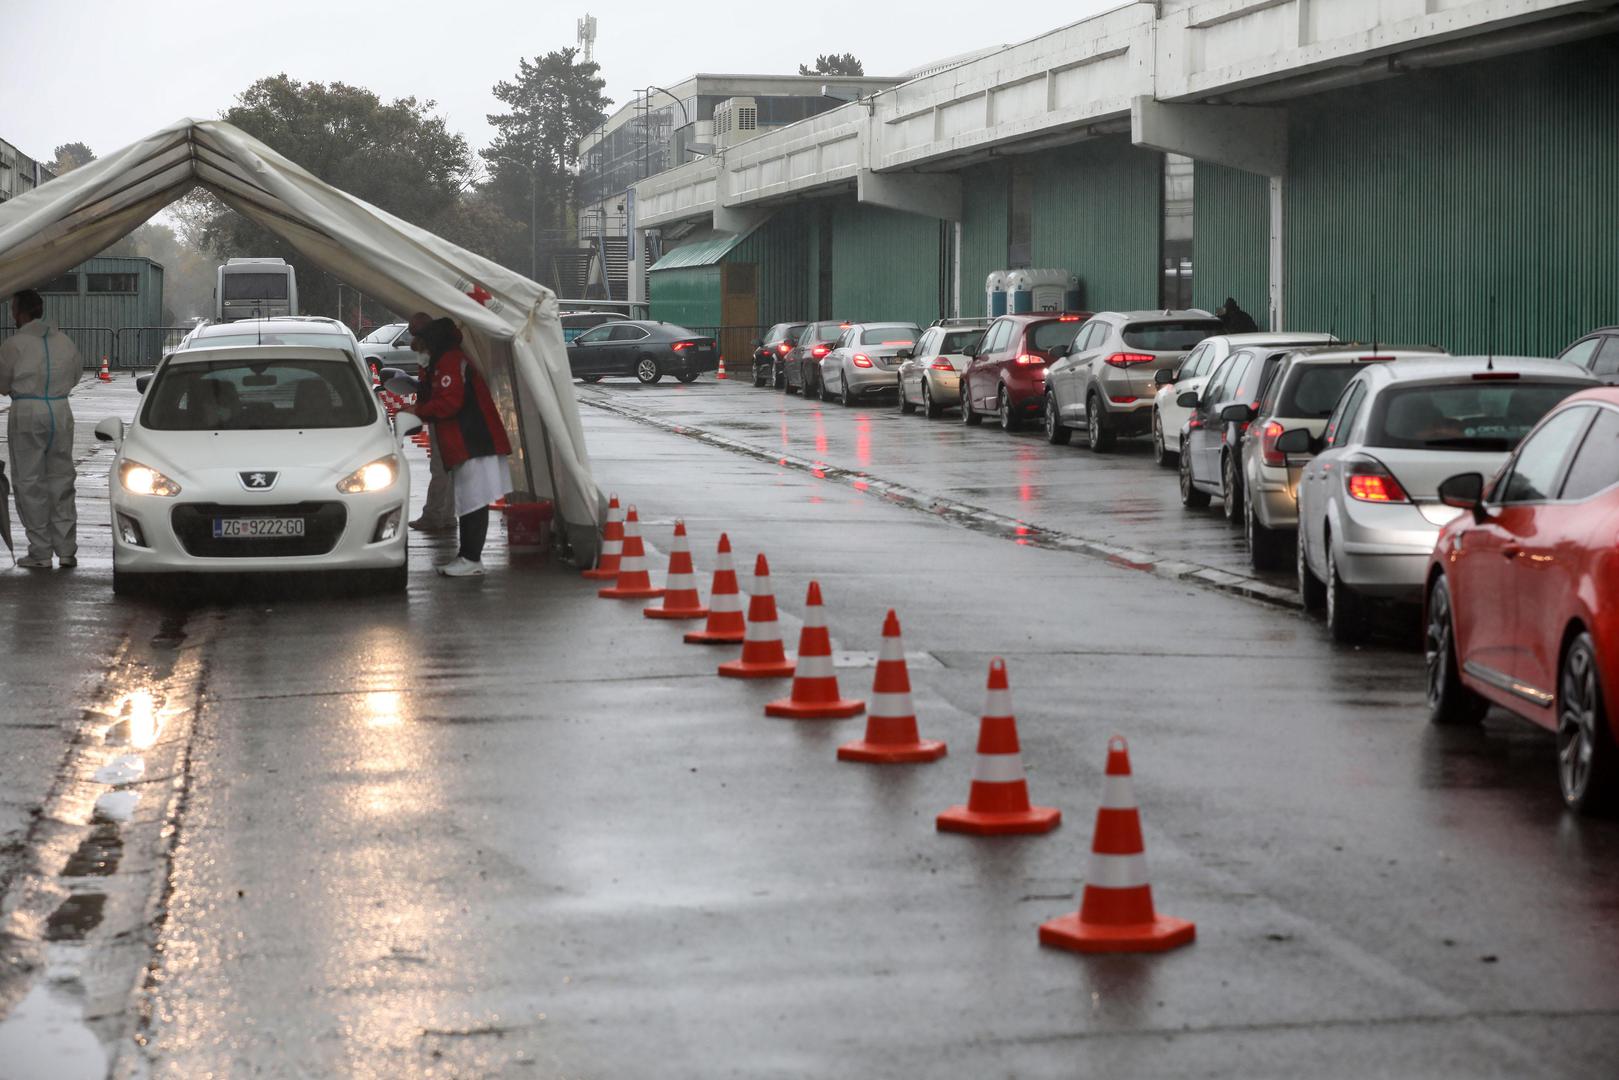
410;319;512;578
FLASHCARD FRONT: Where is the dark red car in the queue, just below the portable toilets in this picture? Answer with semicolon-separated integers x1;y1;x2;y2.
962;311;1091;431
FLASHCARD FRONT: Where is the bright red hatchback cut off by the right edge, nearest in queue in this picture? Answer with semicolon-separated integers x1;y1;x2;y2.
1425;387;1619;813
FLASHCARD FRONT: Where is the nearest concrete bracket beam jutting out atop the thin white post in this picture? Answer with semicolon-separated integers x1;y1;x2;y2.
1130;96;1287;176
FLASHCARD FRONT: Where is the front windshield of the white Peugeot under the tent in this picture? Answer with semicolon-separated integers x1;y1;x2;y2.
141;356;377;431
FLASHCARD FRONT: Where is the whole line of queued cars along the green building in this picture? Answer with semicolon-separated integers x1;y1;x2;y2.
753;309;1619;813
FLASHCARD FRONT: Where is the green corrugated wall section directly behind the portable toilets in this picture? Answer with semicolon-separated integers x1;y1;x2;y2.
1028;138;1164;311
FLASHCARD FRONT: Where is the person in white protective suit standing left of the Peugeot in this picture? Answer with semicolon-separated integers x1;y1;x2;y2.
0;288;83;570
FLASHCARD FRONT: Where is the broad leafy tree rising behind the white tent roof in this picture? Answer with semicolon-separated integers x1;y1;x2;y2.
178;74;473;313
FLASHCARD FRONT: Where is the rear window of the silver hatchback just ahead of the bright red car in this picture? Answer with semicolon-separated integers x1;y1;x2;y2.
1366;379;1580;452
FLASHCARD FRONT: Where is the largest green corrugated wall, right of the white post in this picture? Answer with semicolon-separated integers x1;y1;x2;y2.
1288;37;1619;355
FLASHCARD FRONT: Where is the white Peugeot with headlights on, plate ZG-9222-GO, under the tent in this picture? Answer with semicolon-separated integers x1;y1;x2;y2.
96;345;421;593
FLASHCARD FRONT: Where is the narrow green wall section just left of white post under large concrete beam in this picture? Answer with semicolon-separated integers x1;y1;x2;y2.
1192;162;1271;330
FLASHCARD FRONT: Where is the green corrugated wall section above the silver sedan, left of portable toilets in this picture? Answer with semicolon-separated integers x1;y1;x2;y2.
832;201;941;325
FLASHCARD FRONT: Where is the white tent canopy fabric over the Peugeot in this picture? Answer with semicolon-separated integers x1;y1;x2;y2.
0;120;604;562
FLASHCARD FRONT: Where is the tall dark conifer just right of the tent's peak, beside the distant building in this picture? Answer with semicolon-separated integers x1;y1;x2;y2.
481;49;612;283
